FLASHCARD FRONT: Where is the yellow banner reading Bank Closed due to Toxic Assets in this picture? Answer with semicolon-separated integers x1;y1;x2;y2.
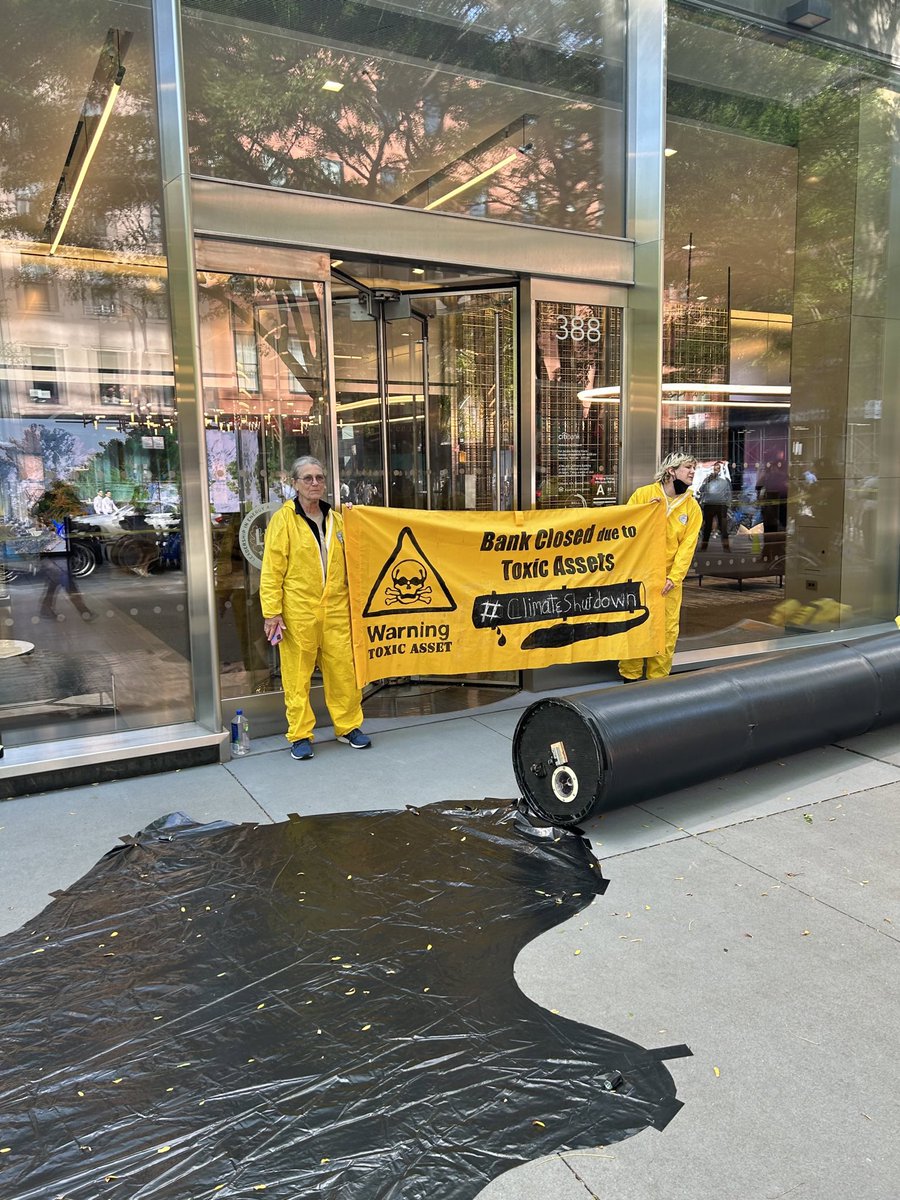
343;504;666;686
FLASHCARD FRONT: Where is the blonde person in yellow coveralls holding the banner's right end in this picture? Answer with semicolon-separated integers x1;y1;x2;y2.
619;454;703;683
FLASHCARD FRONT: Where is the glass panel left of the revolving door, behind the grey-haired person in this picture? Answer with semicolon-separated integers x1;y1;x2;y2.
198;271;329;698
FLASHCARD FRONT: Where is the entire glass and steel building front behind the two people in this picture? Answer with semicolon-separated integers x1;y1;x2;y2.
0;0;900;774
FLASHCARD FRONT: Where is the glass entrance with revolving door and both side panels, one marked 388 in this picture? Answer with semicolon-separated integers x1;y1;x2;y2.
197;239;622;727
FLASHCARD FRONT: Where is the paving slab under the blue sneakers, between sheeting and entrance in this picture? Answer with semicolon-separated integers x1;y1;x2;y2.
228;716;518;821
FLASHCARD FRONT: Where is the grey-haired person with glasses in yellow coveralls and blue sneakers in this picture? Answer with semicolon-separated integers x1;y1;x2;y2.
259;455;372;760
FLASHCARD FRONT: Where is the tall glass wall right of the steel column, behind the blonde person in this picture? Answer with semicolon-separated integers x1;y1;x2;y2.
661;4;900;643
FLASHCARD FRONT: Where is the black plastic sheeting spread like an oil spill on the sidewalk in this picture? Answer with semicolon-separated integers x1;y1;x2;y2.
0;800;690;1200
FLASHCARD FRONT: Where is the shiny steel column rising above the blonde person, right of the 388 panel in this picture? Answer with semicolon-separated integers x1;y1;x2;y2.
619;0;666;502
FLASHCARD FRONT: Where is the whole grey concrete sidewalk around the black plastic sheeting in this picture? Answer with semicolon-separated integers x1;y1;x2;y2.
0;695;900;1200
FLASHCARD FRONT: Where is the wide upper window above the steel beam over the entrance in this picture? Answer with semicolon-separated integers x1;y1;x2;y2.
185;0;624;235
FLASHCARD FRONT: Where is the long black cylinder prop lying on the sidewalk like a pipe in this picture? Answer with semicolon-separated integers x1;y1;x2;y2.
512;634;900;826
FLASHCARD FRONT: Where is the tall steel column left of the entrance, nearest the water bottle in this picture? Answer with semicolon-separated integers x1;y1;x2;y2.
152;0;222;730
